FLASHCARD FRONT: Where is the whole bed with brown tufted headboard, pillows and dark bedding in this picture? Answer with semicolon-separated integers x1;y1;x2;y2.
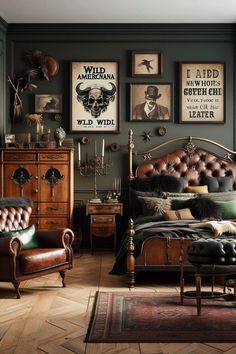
111;130;236;287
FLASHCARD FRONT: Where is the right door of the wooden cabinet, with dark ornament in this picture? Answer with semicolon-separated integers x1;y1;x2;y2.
39;164;70;202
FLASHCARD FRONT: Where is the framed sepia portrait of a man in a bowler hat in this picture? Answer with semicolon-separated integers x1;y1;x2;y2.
130;83;173;122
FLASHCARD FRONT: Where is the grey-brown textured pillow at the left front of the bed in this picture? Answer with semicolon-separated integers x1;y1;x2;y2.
138;197;171;216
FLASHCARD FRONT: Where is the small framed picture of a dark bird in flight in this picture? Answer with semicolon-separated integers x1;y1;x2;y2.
132;51;163;77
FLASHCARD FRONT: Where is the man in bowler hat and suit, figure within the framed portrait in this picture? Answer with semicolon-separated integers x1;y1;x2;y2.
132;85;170;120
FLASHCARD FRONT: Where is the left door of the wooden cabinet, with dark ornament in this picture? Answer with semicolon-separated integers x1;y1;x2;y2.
3;163;39;201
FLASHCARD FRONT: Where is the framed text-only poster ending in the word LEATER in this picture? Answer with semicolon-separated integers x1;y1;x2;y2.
179;62;225;124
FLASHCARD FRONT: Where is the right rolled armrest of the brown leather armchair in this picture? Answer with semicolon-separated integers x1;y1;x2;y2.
36;229;74;248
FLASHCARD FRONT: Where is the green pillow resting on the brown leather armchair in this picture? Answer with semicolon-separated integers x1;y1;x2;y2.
0;225;40;250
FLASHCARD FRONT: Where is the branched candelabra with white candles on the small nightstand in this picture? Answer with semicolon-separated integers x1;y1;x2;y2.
78;139;113;203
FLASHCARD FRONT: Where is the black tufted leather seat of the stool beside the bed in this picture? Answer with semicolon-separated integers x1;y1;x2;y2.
188;238;236;265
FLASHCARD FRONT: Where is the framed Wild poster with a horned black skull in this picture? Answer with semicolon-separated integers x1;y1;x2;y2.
71;61;119;133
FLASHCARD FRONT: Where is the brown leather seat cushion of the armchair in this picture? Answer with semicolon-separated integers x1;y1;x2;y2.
19;248;67;274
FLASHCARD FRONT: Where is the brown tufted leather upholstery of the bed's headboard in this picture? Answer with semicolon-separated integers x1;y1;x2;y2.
135;148;236;189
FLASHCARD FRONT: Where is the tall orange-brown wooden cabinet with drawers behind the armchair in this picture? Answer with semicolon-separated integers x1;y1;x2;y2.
0;148;74;229
